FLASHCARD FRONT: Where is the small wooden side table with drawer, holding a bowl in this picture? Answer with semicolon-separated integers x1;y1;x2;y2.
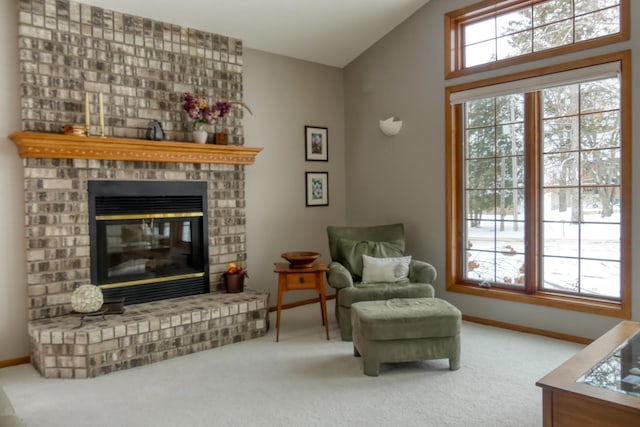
273;260;329;342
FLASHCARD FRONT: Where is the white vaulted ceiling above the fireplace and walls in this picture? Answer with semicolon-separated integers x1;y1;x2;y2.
78;0;429;68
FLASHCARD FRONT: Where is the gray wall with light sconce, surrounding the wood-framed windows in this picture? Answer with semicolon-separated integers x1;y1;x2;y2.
344;0;640;338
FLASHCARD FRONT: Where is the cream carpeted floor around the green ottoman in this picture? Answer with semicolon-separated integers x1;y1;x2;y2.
0;301;583;427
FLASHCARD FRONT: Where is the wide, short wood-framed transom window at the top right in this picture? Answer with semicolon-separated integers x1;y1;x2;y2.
445;0;629;77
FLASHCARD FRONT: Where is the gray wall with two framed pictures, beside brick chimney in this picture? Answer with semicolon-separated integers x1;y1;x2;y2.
243;48;346;306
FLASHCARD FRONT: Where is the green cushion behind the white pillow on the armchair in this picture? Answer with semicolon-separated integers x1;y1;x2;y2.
338;239;404;279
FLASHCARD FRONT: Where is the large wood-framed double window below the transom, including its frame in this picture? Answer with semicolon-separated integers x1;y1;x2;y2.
448;52;630;316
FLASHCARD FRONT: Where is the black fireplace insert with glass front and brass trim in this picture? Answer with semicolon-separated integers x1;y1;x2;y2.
88;181;209;304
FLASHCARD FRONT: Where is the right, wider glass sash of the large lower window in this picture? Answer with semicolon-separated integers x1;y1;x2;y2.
541;77;622;299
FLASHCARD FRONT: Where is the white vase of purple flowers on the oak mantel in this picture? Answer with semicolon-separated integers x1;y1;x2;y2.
182;93;251;144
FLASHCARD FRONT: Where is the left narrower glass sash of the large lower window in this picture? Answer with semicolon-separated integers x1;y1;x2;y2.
464;93;525;287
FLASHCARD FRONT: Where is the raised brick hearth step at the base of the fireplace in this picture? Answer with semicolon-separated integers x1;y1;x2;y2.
29;289;269;378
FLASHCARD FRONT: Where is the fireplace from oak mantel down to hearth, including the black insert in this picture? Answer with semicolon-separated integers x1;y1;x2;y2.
11;132;269;378
